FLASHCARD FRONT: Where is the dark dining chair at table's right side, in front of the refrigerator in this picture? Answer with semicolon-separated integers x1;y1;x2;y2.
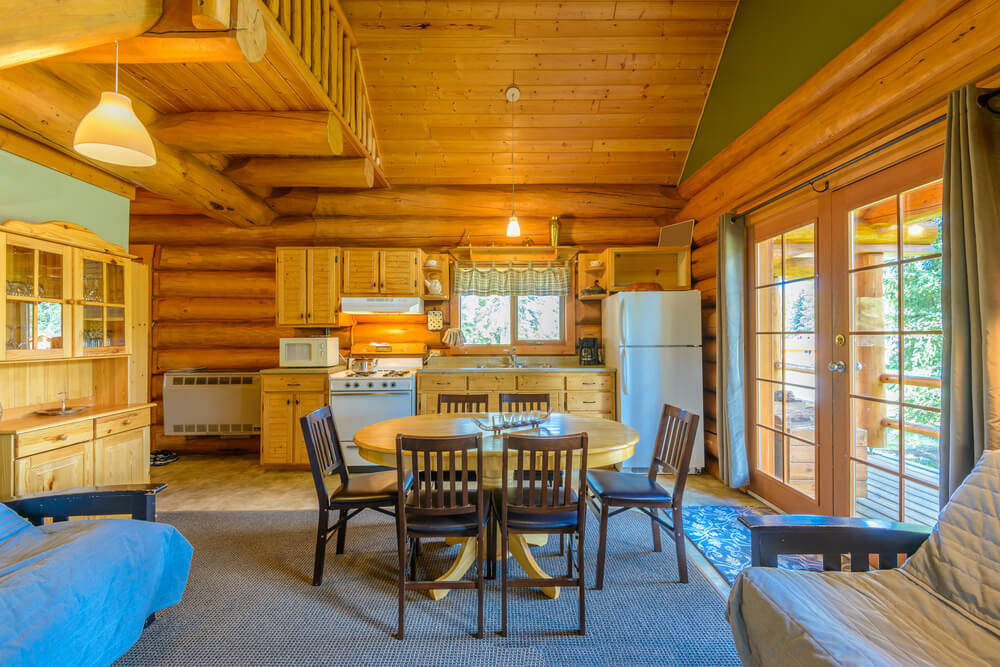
587;404;698;590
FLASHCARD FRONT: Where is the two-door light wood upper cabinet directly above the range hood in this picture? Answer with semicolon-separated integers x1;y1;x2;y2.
344;248;420;296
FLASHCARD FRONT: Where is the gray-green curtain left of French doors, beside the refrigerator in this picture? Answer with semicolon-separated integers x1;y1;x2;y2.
715;215;750;488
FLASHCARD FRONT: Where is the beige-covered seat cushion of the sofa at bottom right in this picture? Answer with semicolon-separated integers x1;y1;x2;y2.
727;567;1000;665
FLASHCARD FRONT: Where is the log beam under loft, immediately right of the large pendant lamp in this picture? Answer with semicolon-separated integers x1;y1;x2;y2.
150;111;344;156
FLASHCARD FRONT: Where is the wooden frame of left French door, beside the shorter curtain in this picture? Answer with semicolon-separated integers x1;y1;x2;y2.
745;197;835;514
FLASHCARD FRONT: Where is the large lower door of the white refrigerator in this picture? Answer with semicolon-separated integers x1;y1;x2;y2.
618;347;705;470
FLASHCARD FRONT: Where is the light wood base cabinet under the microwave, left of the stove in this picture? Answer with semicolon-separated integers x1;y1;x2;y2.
260;373;329;467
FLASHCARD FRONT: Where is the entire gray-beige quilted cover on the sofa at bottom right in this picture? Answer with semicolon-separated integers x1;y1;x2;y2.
726;450;1000;665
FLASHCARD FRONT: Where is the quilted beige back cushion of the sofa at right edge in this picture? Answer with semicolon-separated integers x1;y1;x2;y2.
902;450;1000;634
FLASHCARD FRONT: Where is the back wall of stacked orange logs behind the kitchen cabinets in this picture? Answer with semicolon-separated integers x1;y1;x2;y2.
130;186;682;451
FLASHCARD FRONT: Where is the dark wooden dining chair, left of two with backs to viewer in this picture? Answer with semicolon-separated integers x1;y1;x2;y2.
396;433;489;639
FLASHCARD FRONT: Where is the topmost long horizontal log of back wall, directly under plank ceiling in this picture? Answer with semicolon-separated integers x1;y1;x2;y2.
268;185;684;218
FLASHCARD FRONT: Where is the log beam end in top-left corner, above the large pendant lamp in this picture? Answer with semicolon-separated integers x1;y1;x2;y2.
0;0;163;69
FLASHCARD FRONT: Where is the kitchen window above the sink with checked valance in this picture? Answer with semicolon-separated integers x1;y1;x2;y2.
452;263;573;353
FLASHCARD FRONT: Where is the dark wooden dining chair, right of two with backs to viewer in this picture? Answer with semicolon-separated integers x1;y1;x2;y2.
500;433;587;636
